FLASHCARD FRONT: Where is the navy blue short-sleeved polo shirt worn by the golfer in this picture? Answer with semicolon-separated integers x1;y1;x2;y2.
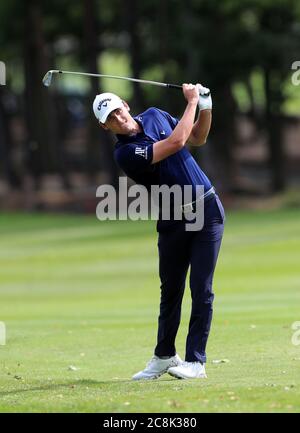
114;107;212;230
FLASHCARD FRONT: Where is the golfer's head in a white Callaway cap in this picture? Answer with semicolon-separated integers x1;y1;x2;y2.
93;93;131;134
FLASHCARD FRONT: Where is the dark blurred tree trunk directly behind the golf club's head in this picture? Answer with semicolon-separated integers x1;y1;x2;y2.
24;0;65;187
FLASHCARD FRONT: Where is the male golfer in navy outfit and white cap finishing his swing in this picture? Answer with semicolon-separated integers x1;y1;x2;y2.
93;84;225;380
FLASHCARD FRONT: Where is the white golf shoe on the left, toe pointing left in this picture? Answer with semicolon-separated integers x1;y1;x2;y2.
132;354;182;380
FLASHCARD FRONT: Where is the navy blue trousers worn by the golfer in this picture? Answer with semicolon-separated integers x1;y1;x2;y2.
154;195;225;363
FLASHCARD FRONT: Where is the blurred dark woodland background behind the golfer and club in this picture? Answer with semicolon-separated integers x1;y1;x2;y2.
0;0;300;211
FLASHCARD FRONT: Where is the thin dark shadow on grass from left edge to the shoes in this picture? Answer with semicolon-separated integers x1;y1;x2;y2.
0;378;176;397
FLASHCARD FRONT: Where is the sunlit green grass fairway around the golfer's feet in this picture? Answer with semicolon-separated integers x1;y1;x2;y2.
0;208;300;412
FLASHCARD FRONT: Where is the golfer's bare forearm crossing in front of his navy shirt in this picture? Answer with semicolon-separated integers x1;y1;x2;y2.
152;102;197;164
